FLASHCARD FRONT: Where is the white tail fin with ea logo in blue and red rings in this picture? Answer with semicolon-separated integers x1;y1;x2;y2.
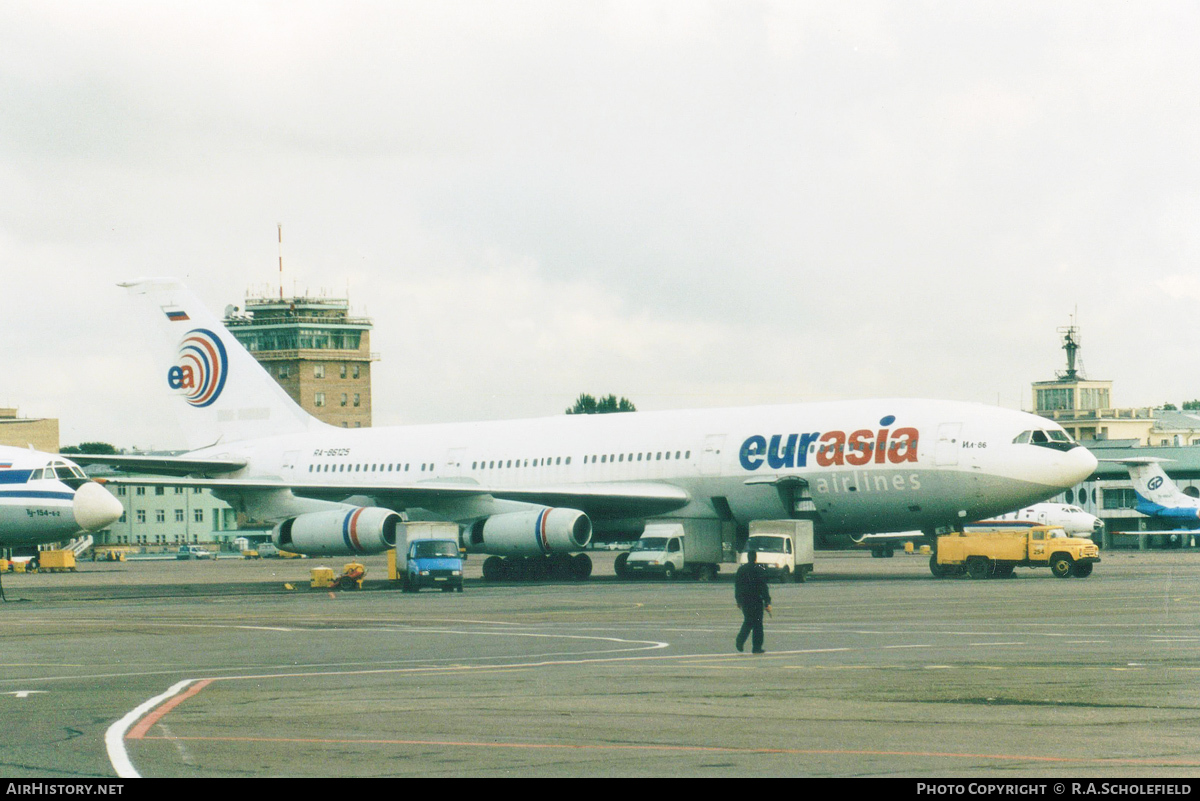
121;278;325;450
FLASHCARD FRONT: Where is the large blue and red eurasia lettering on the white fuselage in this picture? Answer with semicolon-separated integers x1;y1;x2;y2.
738;415;920;470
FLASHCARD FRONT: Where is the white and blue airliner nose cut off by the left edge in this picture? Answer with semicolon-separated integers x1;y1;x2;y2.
0;446;122;548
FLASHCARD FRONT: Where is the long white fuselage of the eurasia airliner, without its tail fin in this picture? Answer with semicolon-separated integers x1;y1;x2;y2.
191;399;1096;535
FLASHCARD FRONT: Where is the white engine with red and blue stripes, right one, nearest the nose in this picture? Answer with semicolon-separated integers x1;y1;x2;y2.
468;506;592;556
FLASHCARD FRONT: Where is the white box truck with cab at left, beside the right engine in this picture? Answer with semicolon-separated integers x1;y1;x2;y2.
616;520;722;579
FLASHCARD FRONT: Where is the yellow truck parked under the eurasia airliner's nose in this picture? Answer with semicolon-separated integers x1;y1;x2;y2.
929;525;1100;578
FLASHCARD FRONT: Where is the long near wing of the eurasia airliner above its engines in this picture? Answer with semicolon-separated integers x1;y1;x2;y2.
98;477;691;519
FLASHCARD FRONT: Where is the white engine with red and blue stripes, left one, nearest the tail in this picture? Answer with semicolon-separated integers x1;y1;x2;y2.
271;506;401;556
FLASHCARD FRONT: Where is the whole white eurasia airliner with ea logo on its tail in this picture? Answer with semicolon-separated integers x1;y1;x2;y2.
76;279;1096;577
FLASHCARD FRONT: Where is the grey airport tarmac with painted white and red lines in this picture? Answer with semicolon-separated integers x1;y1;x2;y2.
0;550;1200;779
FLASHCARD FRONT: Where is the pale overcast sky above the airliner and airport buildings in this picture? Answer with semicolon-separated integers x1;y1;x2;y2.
0;0;1200;447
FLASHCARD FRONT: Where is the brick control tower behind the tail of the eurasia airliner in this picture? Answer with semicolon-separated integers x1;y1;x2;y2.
224;294;378;428
